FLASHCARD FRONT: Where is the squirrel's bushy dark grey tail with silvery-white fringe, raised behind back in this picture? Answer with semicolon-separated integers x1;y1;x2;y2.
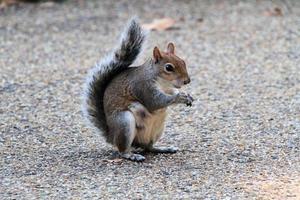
83;19;145;138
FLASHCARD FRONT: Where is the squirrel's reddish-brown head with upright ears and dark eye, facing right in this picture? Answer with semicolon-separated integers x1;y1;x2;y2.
153;43;191;88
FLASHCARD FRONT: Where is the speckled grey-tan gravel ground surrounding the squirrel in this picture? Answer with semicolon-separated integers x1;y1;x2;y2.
0;0;300;199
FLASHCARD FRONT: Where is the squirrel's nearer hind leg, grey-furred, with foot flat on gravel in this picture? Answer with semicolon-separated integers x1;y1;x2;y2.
108;111;145;162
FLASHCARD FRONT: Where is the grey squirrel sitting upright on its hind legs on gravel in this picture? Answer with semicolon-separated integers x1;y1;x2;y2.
83;19;193;161
